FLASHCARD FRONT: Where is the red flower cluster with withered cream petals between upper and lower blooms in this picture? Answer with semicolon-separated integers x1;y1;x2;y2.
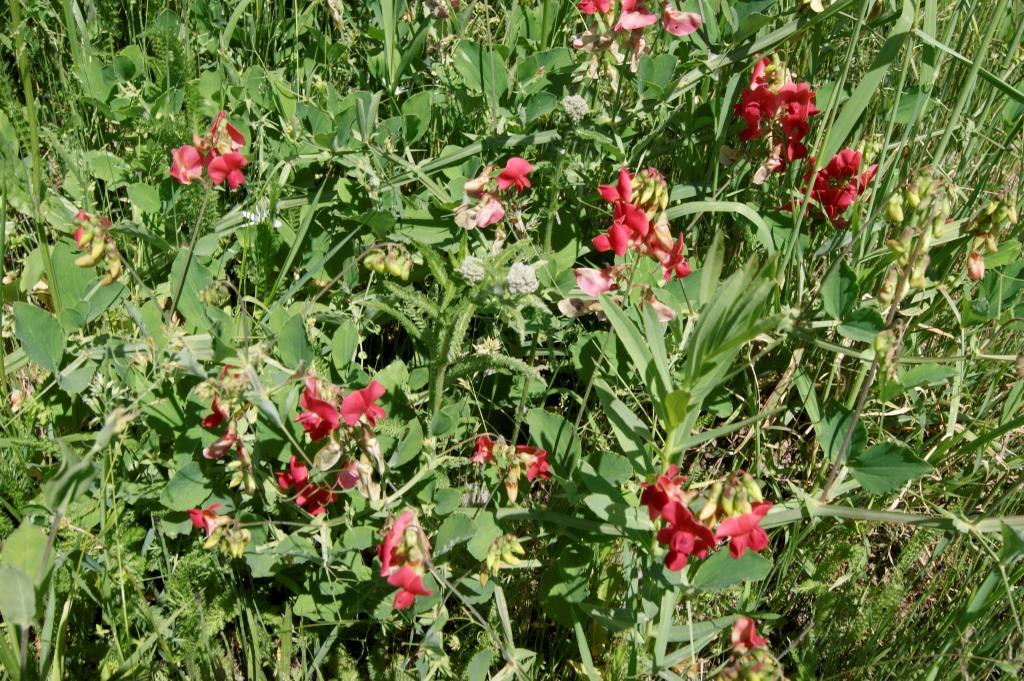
278;373;387;515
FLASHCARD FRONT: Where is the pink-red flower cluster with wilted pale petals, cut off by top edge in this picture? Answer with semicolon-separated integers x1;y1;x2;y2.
572;0;701;77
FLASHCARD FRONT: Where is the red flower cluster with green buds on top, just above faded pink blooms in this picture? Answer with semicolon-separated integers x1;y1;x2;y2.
593;168;691;281
